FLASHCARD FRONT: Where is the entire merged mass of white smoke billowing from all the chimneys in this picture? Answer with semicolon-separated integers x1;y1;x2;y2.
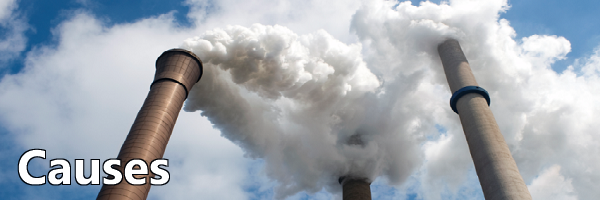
183;0;600;199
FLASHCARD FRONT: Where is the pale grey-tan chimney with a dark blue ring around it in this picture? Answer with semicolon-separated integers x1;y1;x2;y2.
438;39;531;200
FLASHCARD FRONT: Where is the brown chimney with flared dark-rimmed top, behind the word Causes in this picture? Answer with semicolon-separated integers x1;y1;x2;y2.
97;49;202;199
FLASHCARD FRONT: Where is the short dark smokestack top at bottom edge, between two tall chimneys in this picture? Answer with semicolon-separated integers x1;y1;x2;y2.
338;176;371;200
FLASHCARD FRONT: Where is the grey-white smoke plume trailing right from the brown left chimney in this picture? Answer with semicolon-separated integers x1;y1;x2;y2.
183;24;428;198
